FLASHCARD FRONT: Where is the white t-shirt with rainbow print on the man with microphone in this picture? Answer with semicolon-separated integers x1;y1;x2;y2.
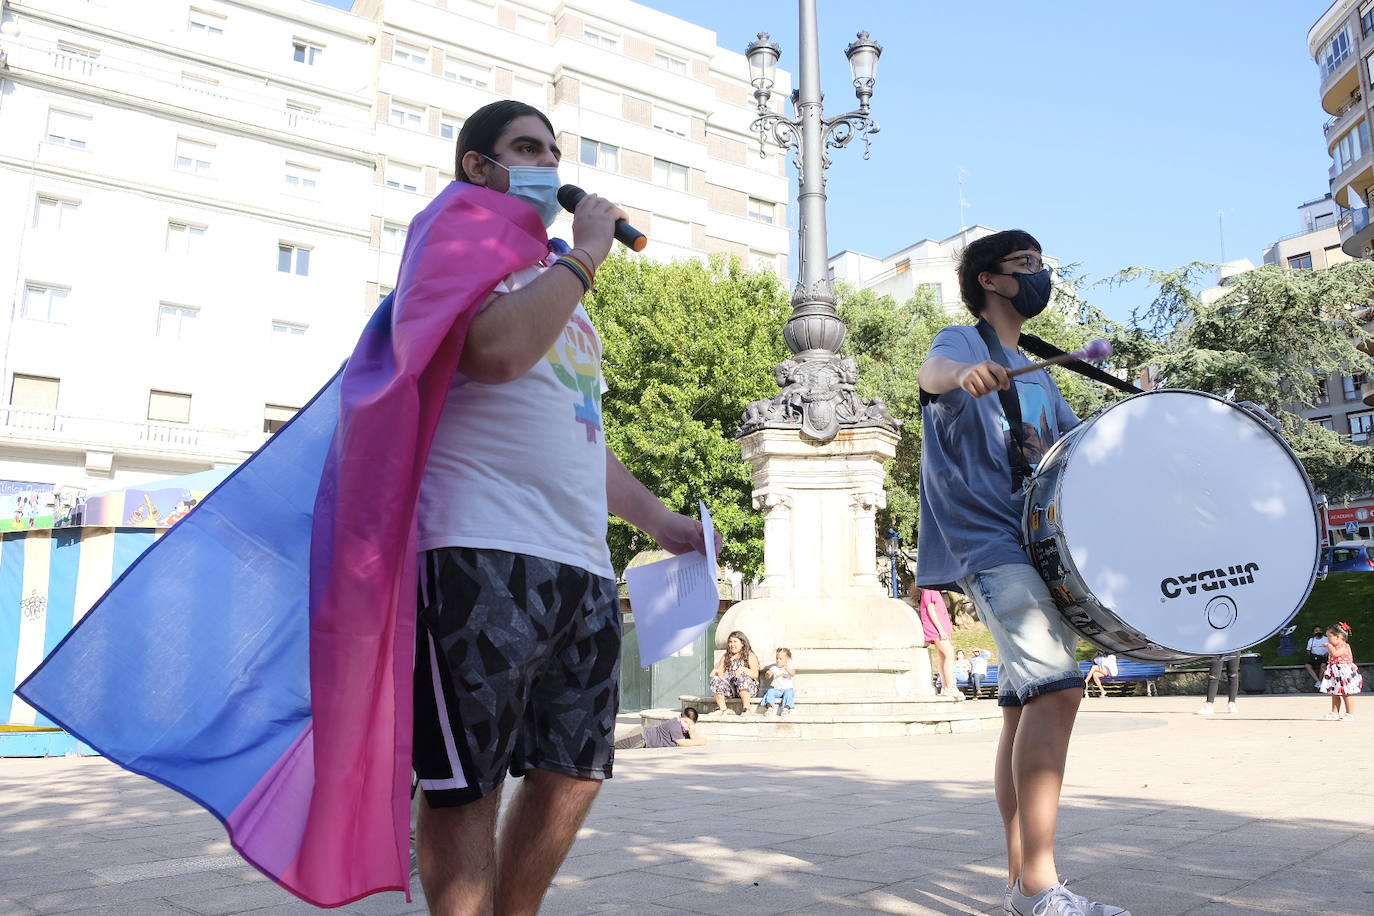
419;265;616;578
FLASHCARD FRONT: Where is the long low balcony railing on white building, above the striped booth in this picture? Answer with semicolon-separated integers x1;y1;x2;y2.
0;407;262;453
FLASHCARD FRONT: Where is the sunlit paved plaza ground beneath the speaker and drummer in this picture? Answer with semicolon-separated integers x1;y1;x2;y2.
0;696;1374;916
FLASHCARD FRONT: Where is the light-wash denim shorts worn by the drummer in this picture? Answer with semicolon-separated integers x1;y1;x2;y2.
959;563;1084;706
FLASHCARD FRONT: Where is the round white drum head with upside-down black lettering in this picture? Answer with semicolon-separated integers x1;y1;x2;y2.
1058;390;1319;655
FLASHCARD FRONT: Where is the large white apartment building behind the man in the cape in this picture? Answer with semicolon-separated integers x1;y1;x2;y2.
0;0;790;508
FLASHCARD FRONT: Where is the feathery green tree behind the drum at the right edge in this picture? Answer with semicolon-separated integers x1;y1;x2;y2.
1113;261;1374;499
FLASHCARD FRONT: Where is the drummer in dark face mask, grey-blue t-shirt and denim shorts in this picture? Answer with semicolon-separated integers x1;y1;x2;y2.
916;229;1129;916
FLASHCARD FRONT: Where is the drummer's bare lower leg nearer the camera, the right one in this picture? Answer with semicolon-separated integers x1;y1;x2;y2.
1011;689;1083;894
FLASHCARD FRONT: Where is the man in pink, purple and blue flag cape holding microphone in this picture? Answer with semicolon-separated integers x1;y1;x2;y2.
18;102;705;915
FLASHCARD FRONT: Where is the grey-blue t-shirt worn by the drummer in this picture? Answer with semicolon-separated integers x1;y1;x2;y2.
916;325;1079;588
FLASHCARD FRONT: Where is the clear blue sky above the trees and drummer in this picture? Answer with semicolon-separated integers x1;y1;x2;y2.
318;0;1330;317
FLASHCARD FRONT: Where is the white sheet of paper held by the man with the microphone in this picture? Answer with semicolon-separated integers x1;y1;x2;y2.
625;503;720;665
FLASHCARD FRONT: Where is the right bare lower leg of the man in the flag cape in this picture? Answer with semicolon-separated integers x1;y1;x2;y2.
496;769;600;916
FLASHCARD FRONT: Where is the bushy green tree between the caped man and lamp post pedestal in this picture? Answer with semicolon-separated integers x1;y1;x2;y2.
585;254;790;577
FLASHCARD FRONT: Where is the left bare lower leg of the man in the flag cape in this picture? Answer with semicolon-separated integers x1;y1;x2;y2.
418;786;502;916
